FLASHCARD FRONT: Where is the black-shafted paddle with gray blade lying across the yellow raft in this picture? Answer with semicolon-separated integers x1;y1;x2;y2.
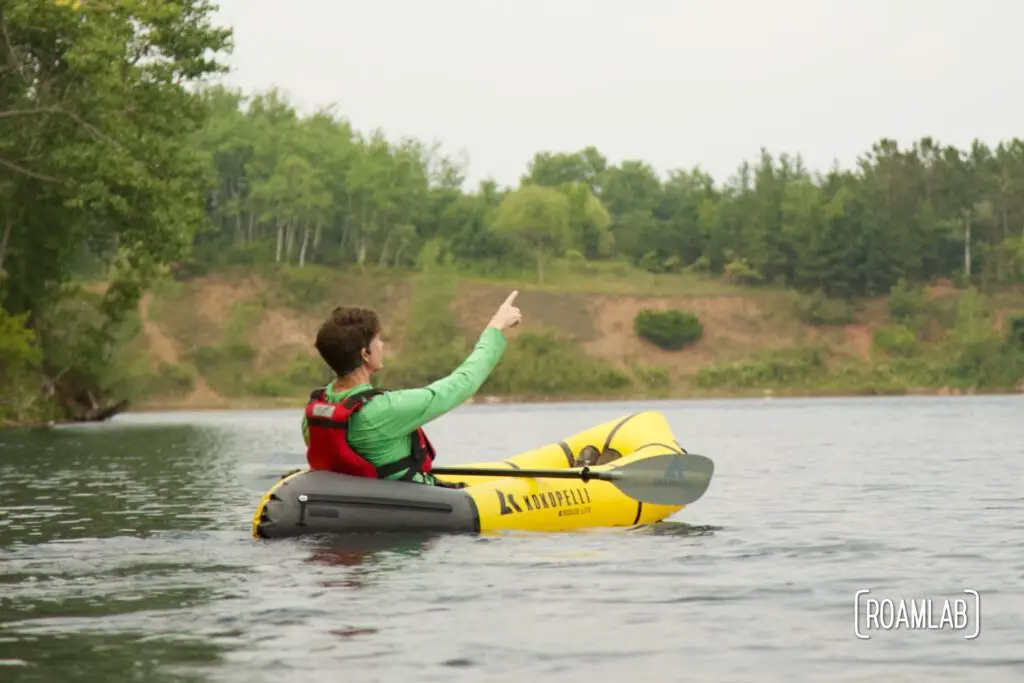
431;453;715;506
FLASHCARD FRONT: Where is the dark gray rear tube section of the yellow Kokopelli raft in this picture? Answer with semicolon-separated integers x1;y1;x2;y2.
257;471;480;539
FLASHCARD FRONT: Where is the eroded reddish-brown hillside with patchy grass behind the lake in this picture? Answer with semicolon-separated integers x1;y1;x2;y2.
123;264;1024;409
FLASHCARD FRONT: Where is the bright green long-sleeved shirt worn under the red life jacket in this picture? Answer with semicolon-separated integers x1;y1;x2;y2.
302;327;506;483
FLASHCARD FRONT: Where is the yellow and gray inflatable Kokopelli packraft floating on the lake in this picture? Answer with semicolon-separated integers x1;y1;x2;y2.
252;412;714;539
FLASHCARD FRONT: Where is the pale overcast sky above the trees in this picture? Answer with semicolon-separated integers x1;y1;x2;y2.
205;0;1024;184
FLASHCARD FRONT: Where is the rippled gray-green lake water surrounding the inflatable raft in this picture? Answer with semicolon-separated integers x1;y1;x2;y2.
0;396;1024;683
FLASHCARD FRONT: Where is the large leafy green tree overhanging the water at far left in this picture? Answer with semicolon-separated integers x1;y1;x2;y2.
0;0;230;421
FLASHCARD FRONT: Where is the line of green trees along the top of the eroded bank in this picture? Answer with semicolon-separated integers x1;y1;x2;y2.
196;81;1024;297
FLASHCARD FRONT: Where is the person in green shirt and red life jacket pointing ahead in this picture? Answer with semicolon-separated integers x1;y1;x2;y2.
302;292;522;485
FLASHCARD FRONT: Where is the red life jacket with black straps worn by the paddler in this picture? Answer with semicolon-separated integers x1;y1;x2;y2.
306;389;436;481
